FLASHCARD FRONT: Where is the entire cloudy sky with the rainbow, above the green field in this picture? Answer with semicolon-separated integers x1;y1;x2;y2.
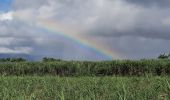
0;0;170;60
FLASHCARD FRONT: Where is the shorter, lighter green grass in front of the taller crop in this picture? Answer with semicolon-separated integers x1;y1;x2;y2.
0;76;170;100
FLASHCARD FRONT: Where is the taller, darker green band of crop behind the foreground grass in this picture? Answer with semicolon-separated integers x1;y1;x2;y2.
0;60;170;76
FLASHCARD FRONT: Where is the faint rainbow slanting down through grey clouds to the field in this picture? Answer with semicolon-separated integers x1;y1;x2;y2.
14;14;123;60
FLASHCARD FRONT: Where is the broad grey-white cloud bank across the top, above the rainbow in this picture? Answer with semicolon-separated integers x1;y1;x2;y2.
14;0;170;39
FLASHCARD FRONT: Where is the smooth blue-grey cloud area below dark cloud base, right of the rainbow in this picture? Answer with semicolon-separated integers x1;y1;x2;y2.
99;36;170;59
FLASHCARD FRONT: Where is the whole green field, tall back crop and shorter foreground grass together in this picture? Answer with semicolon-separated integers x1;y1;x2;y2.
0;60;170;100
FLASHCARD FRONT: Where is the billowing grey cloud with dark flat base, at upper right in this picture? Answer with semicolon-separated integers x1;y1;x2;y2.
85;0;170;39
